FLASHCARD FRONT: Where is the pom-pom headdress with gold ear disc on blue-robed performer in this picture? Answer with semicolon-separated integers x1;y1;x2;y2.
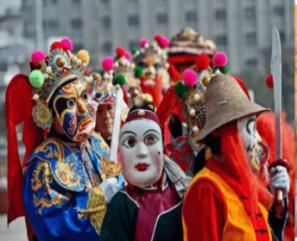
29;38;90;129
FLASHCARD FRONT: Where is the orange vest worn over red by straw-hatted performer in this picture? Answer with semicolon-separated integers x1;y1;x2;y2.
183;168;272;241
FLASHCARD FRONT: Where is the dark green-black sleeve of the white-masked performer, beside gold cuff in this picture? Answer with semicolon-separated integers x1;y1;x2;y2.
100;192;137;241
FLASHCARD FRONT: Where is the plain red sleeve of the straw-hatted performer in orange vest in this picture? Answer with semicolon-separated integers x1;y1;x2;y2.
183;178;227;241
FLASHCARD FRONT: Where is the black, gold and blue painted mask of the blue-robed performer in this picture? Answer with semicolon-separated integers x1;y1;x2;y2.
53;79;95;142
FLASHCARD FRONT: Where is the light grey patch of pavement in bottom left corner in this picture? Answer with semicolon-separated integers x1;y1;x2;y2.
0;215;27;241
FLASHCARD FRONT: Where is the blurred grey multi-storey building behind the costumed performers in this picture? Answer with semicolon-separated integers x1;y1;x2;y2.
22;0;294;73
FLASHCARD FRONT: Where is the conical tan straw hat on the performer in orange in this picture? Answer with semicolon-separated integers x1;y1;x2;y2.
195;74;269;141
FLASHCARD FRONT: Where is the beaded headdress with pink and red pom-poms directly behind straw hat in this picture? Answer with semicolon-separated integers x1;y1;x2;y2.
174;52;228;148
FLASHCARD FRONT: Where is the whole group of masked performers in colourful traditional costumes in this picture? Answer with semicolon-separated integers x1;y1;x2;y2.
5;28;295;241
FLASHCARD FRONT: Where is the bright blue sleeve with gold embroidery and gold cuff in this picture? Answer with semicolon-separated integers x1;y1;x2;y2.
24;159;106;241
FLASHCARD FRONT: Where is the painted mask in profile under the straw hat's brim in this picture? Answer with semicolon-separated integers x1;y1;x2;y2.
237;116;268;174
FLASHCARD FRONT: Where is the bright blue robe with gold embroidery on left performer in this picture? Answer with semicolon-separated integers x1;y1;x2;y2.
24;135;124;241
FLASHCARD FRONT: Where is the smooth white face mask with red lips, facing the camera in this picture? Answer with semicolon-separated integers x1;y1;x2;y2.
120;119;164;188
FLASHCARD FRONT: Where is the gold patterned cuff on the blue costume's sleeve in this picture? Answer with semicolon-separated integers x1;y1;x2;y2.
78;186;106;234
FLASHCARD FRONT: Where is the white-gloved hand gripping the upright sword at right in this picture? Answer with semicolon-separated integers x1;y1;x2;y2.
269;165;290;196
